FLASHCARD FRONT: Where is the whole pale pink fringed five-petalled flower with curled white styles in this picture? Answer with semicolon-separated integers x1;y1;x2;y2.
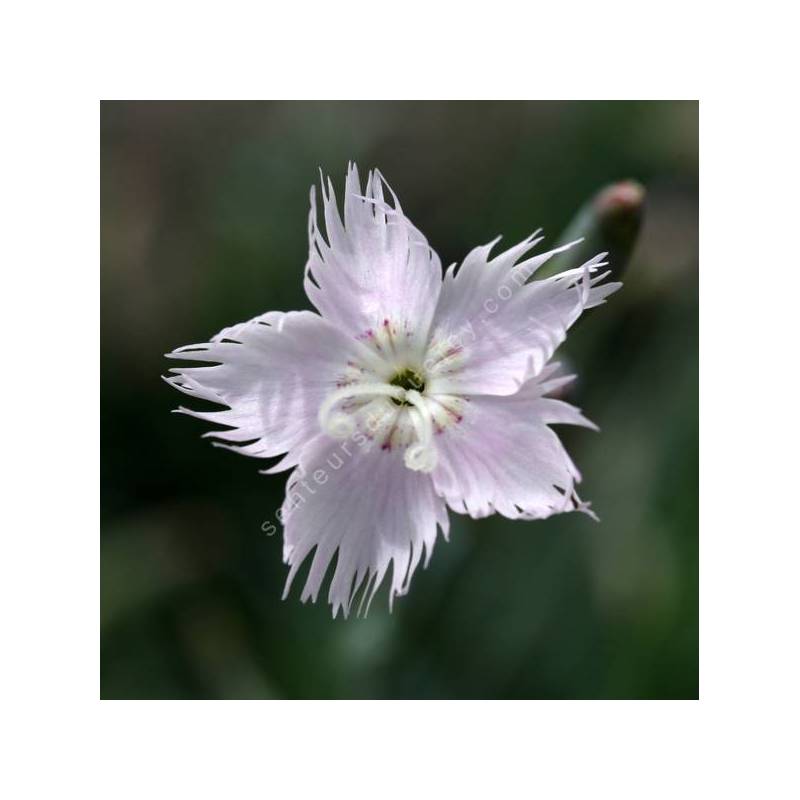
166;165;620;617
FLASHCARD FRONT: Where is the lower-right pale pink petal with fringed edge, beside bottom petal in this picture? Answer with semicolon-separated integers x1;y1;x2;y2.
433;379;593;519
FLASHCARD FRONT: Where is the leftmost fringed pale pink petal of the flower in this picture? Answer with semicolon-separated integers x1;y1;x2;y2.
166;311;372;472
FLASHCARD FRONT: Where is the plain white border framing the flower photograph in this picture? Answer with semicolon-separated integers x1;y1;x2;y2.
2;2;800;798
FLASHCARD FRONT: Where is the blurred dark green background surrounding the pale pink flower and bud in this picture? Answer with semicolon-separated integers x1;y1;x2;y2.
101;102;698;698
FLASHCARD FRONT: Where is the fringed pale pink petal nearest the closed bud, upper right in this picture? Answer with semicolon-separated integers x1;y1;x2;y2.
430;234;621;395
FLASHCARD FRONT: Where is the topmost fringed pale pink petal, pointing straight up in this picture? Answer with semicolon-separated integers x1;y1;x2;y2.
305;164;442;343
